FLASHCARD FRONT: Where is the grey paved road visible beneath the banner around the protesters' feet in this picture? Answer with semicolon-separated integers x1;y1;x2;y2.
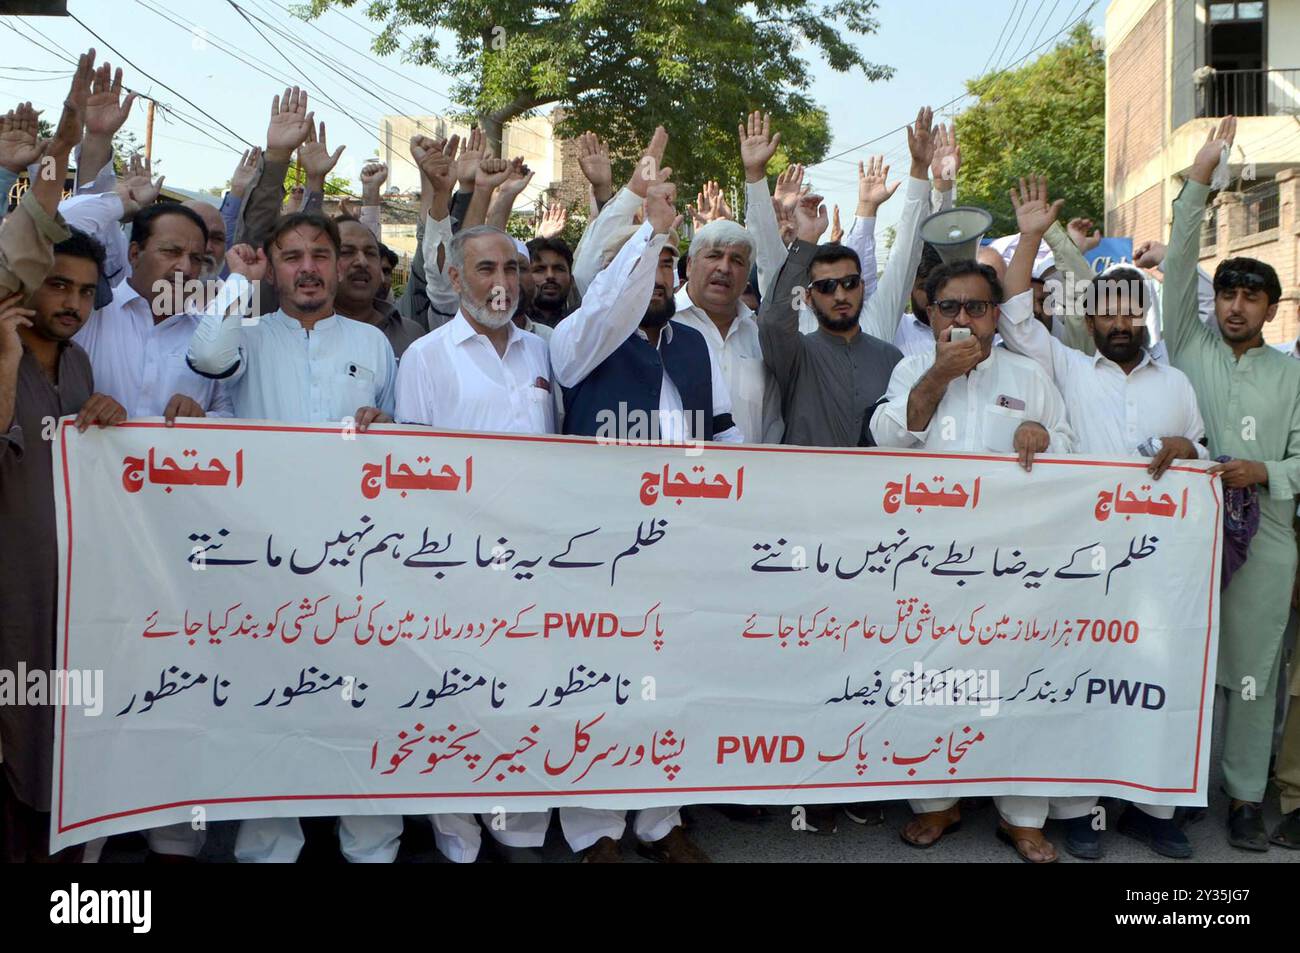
103;696;1300;863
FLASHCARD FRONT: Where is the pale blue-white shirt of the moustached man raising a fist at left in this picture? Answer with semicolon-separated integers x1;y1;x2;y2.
189;274;397;424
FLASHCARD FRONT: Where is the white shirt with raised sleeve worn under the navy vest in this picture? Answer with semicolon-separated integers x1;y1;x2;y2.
550;222;745;443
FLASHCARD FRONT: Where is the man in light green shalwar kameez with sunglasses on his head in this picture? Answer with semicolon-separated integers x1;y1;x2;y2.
1164;116;1300;852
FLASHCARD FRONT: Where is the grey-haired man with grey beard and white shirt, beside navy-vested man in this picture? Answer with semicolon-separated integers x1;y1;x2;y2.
397;225;555;863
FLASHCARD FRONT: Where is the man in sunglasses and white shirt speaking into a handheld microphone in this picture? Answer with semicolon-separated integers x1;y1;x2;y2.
870;261;1074;863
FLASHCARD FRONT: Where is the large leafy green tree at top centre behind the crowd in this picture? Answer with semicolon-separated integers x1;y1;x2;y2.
309;0;893;198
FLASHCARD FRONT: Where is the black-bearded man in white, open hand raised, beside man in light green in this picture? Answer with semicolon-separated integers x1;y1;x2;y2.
997;177;1209;859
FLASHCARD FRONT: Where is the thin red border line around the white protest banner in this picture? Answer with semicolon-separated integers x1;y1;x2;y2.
57;417;1223;833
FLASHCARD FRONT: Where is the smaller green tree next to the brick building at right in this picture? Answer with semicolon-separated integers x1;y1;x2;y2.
957;23;1106;235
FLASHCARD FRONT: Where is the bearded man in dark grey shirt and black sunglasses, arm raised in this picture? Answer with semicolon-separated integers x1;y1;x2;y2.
758;195;902;447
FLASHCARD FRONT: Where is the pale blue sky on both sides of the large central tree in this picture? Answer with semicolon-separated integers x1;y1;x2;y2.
0;0;1105;237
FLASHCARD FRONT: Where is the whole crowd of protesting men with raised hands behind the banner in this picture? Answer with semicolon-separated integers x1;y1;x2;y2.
0;51;1300;863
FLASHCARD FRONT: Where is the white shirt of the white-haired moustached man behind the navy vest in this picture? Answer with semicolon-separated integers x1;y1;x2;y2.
672;285;785;443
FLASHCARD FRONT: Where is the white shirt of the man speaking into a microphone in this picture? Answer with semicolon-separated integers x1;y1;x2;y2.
871;347;1074;454
